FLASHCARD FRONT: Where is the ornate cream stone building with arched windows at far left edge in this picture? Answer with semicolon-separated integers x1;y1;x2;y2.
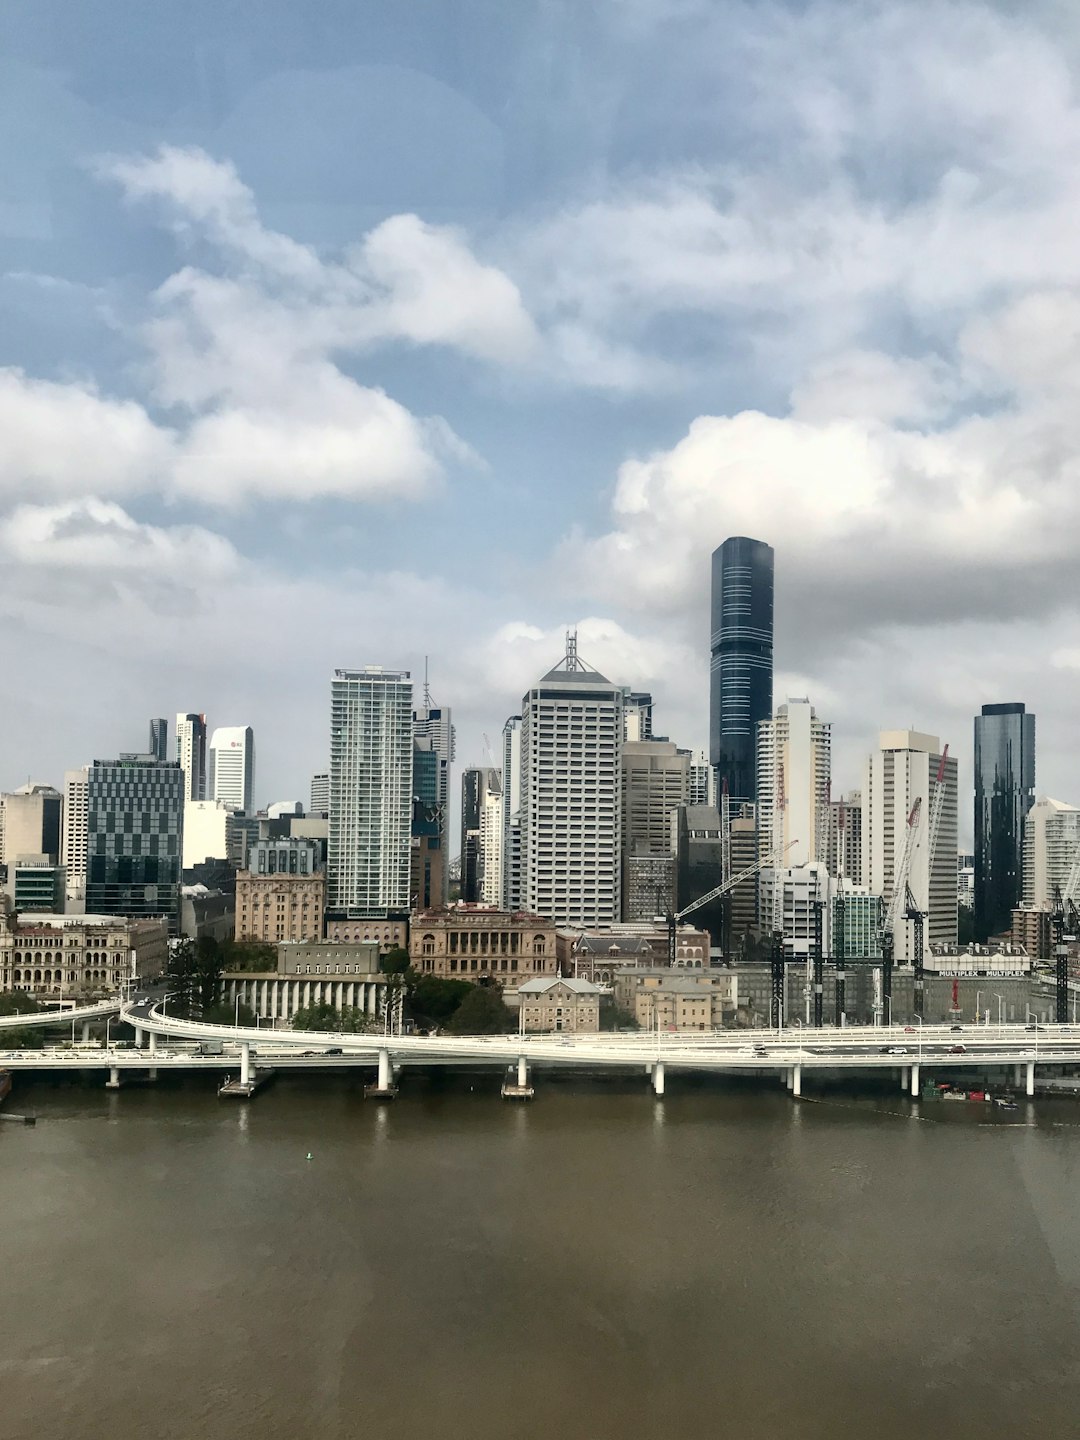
0;913;168;999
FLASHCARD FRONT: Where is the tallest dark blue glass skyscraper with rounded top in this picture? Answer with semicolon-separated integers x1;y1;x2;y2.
708;536;773;802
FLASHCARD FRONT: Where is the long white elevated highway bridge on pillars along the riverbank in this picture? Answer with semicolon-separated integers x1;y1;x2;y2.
0;1001;1080;1097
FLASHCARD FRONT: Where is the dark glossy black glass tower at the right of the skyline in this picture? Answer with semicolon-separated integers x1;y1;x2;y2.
975;704;1035;940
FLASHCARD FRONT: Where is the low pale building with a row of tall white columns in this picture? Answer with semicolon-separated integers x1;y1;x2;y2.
222;942;387;1030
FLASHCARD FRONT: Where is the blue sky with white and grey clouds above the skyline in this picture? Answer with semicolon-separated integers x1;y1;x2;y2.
0;0;1080;828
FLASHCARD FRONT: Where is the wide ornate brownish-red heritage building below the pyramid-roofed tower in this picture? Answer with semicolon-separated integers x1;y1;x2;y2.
409;904;557;985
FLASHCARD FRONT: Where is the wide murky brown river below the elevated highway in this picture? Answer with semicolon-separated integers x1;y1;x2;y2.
0;1073;1080;1440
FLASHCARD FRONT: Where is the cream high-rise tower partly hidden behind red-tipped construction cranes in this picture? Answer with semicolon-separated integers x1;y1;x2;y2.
863;730;956;962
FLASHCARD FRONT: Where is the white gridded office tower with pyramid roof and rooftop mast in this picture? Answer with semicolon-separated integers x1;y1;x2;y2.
521;634;624;926
